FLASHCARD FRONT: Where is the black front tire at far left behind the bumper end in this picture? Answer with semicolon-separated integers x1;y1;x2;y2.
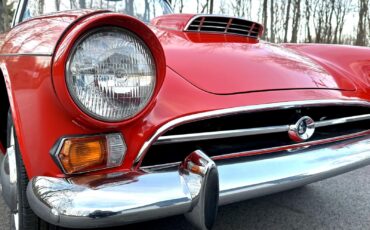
7;112;62;230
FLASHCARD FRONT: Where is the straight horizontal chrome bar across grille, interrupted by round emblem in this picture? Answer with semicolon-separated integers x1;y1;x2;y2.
153;114;370;145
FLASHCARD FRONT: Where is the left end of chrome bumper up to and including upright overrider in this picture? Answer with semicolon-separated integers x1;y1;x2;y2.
27;151;219;229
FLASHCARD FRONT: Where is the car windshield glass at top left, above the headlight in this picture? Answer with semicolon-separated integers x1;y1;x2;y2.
22;0;172;23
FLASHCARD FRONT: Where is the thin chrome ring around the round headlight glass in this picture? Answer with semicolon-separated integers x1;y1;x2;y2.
65;26;157;123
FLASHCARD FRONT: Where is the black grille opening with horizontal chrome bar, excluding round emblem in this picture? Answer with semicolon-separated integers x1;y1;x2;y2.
141;103;370;166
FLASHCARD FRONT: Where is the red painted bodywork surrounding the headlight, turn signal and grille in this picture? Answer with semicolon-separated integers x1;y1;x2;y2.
0;10;370;177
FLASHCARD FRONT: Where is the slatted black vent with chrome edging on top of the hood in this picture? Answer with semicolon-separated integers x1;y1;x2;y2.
185;15;263;39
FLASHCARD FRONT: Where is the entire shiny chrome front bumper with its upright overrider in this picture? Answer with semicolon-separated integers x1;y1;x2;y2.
27;135;370;228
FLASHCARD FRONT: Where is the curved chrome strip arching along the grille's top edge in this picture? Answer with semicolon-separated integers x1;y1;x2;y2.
134;100;370;164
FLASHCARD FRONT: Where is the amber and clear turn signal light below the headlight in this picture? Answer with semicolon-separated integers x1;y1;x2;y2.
57;134;126;174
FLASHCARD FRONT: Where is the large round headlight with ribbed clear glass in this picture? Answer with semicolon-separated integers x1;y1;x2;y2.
66;27;156;122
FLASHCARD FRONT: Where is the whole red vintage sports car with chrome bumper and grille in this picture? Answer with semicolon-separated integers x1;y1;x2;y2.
0;0;370;230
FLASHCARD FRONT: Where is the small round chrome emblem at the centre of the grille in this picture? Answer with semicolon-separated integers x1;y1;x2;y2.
288;116;315;142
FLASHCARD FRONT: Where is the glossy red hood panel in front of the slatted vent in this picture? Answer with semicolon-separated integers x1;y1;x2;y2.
153;15;355;94
